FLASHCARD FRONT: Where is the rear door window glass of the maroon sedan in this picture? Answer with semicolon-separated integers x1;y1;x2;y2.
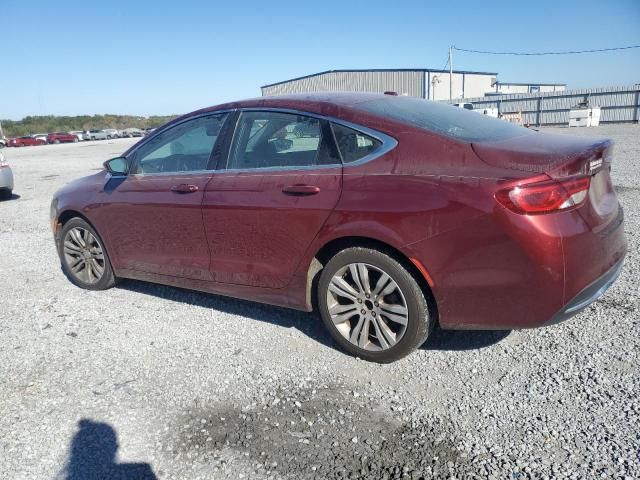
227;112;340;169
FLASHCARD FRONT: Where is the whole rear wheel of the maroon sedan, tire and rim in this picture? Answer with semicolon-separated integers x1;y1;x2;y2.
318;247;434;363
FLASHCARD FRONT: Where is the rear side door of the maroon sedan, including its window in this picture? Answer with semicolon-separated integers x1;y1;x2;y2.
203;110;342;288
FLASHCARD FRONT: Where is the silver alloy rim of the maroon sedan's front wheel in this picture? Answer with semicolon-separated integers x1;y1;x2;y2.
63;227;105;284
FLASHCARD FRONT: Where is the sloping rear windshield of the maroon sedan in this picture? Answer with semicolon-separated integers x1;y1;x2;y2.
356;97;532;142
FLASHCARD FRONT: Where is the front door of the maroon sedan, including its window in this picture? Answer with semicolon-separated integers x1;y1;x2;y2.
100;114;227;280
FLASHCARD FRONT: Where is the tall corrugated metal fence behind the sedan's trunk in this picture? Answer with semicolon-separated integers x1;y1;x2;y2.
454;84;640;126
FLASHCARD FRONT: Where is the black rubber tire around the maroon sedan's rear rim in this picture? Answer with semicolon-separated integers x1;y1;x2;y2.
317;247;435;363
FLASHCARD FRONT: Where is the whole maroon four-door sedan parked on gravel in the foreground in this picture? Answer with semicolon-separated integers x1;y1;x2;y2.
51;94;626;362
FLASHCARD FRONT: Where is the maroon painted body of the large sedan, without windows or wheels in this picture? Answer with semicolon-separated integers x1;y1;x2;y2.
52;94;626;329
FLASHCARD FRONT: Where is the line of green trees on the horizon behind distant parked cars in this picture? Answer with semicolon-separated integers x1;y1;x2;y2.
0;114;177;137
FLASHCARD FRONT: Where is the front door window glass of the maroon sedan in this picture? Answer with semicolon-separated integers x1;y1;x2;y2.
133;114;227;174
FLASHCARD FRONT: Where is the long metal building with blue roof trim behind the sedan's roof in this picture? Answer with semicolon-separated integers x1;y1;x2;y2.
261;69;498;100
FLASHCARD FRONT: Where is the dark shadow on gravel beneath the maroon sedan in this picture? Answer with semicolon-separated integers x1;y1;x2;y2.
118;280;511;351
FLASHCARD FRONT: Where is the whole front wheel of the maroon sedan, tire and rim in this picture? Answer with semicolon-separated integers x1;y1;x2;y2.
58;218;116;290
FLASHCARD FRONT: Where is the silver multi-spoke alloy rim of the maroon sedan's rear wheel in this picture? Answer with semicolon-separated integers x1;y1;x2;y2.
327;263;409;351
